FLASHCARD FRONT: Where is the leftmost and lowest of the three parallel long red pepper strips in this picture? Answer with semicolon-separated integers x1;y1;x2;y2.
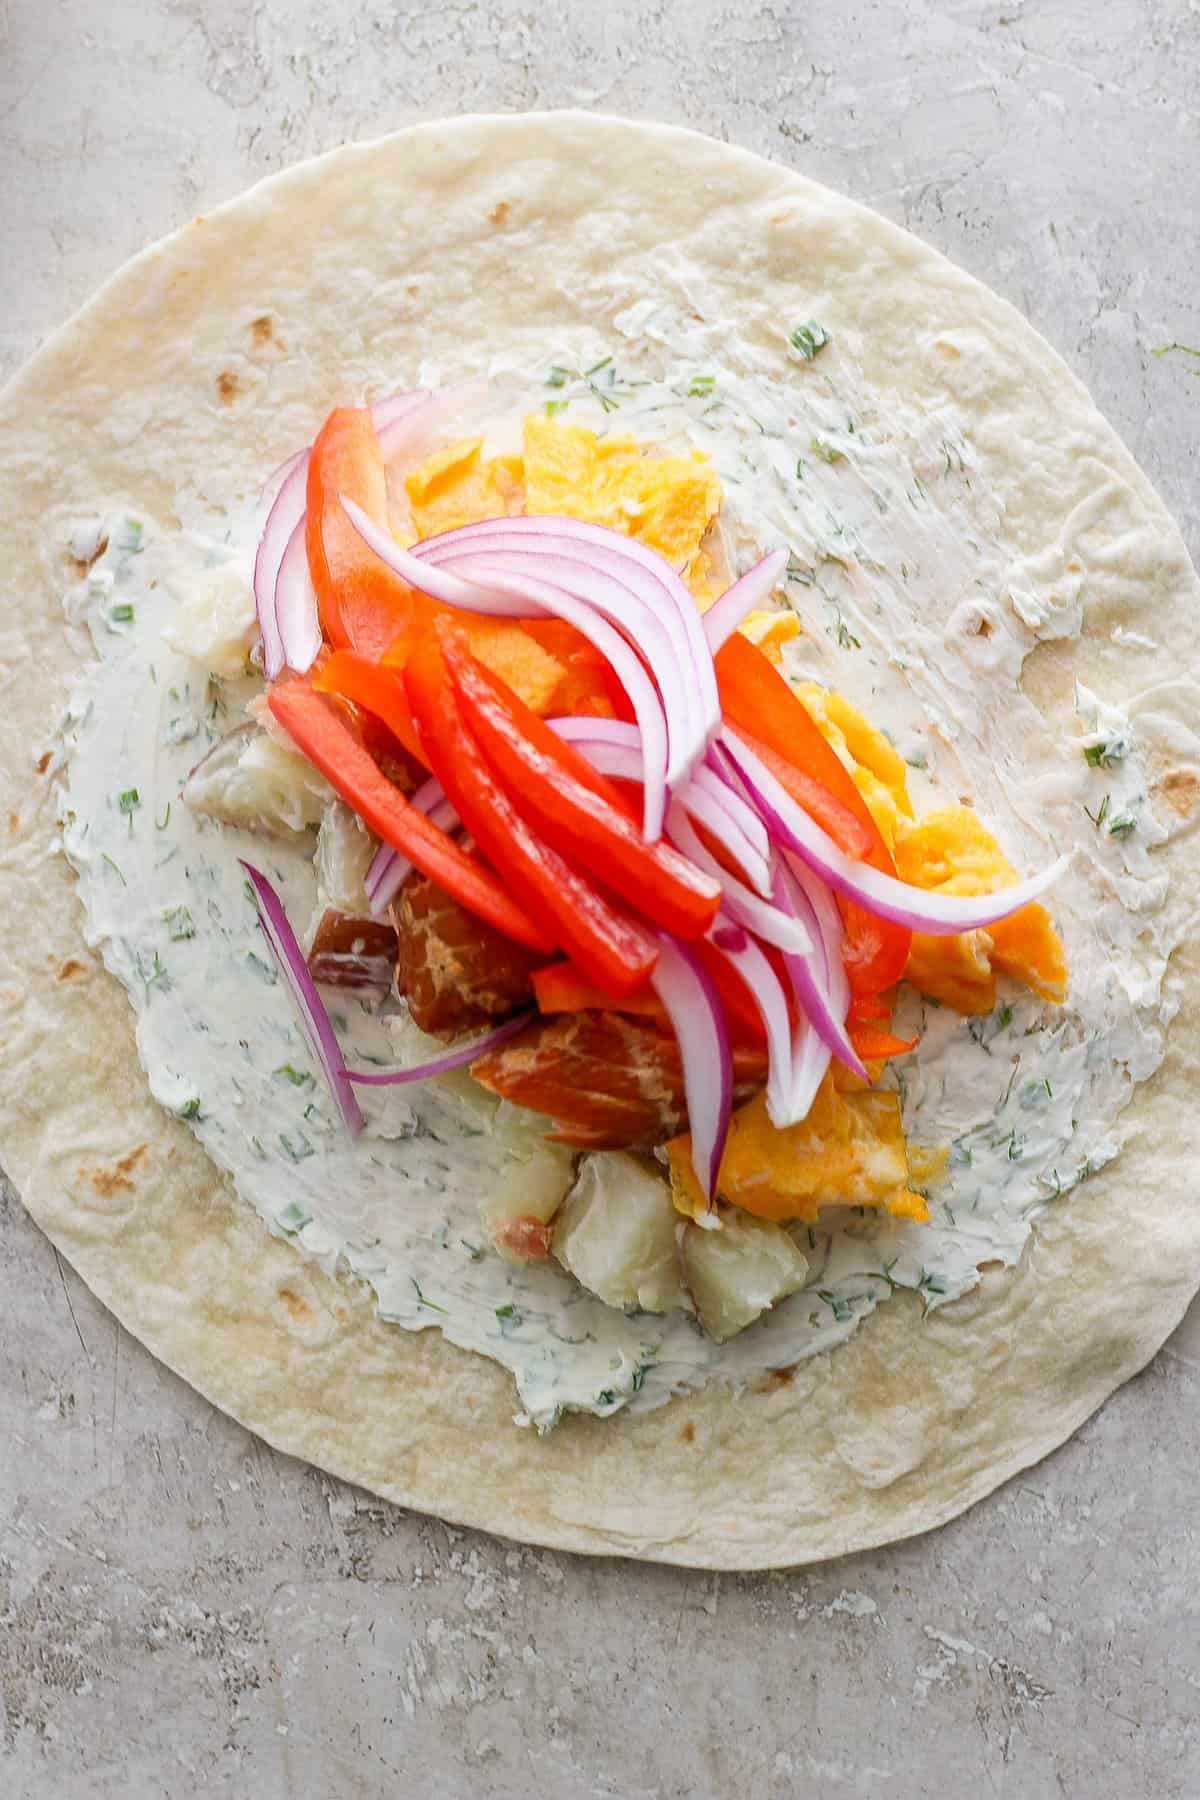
268;680;554;950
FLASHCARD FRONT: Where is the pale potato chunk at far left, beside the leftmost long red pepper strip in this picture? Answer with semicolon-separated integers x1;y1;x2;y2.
184;725;333;837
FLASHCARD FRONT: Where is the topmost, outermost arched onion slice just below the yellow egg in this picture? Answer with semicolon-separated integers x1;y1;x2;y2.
417;513;721;736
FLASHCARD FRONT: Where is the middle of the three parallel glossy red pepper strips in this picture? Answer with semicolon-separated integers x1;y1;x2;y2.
405;635;658;999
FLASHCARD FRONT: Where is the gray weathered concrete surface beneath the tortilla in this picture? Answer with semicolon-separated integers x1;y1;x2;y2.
0;0;1200;1800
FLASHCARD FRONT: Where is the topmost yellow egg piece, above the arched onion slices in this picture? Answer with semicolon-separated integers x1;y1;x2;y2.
524;412;721;599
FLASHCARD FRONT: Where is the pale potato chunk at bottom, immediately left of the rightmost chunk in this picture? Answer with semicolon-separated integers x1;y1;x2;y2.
554;1150;687;1312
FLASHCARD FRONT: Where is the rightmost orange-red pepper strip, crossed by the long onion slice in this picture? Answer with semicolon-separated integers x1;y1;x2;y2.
716;632;912;995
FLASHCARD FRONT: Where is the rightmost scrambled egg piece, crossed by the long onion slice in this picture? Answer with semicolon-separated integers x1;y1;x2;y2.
894;806;1067;1013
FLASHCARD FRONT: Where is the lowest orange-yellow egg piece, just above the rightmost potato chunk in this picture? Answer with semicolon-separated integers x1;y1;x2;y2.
667;1075;928;1219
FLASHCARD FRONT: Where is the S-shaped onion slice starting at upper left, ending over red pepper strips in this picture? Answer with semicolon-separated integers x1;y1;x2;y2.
342;495;667;842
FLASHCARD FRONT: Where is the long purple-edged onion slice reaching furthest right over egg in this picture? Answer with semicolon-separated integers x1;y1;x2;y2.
720;729;1067;938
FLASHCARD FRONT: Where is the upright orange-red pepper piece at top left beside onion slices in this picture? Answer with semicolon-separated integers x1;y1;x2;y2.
304;407;434;659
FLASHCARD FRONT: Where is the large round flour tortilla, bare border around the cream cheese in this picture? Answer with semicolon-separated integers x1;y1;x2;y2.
0;113;1200;1568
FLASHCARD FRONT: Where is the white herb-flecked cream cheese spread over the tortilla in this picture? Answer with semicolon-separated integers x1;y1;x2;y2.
63;343;1178;1429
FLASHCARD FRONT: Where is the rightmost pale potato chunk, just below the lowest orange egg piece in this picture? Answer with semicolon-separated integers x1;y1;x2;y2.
680;1208;808;1343
